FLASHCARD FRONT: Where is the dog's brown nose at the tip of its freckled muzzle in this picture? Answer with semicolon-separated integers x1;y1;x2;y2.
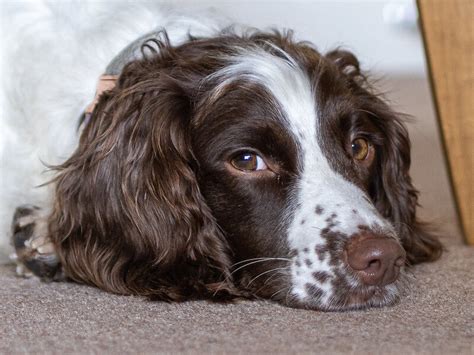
345;232;406;286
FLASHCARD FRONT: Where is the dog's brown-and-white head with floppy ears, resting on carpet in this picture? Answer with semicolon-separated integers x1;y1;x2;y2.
50;33;441;309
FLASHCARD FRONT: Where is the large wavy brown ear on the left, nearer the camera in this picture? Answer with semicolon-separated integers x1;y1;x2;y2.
49;57;237;300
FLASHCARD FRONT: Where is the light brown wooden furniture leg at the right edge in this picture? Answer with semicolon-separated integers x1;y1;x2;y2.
418;0;474;245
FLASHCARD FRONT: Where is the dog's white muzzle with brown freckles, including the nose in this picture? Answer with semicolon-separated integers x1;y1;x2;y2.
289;178;405;309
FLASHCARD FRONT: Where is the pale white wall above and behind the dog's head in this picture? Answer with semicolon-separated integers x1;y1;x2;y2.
172;0;424;75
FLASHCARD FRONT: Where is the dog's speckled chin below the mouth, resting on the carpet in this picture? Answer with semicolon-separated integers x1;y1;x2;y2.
278;281;402;312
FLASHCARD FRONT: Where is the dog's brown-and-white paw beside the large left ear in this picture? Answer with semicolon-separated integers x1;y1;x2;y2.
12;205;65;281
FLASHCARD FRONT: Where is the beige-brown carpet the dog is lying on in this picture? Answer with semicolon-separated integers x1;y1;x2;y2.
0;79;474;354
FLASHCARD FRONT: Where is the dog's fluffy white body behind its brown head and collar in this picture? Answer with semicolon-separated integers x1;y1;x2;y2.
0;1;228;263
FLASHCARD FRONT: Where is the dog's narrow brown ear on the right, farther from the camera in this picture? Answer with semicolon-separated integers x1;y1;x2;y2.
327;50;443;264
